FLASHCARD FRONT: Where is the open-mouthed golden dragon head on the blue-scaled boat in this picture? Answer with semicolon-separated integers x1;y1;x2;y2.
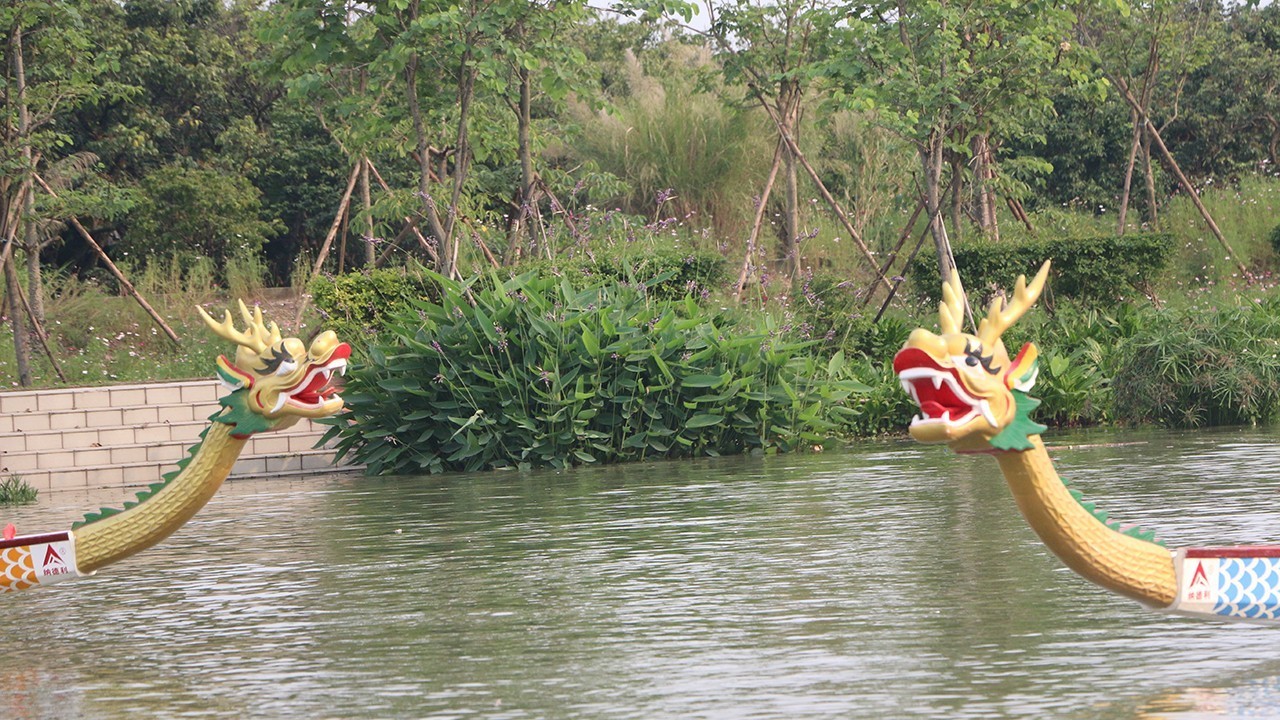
893;261;1050;452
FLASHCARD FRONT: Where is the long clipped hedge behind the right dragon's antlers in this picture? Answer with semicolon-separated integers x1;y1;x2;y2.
908;233;1172;305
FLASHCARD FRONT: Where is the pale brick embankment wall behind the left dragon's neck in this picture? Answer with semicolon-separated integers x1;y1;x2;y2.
0;380;353;492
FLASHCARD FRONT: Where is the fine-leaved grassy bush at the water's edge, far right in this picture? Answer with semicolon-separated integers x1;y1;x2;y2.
1112;299;1280;427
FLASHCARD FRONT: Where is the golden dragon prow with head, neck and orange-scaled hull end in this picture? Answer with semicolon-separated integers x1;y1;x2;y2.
0;302;351;593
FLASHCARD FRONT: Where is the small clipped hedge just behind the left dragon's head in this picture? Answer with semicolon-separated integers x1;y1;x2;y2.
308;268;439;351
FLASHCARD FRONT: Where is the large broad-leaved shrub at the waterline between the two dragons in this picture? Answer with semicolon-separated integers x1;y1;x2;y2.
320;273;865;474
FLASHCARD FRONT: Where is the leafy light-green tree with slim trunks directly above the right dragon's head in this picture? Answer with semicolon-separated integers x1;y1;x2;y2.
829;0;1091;279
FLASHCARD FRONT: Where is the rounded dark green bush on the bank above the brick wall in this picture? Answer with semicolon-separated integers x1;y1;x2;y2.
119;165;276;264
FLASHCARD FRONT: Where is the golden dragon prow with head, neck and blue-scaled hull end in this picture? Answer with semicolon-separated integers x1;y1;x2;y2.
893;261;1280;623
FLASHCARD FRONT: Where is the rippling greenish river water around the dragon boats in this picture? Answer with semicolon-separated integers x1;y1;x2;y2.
0;422;1280;719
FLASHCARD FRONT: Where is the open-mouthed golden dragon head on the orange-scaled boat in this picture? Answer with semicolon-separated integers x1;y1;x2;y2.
197;301;351;434
